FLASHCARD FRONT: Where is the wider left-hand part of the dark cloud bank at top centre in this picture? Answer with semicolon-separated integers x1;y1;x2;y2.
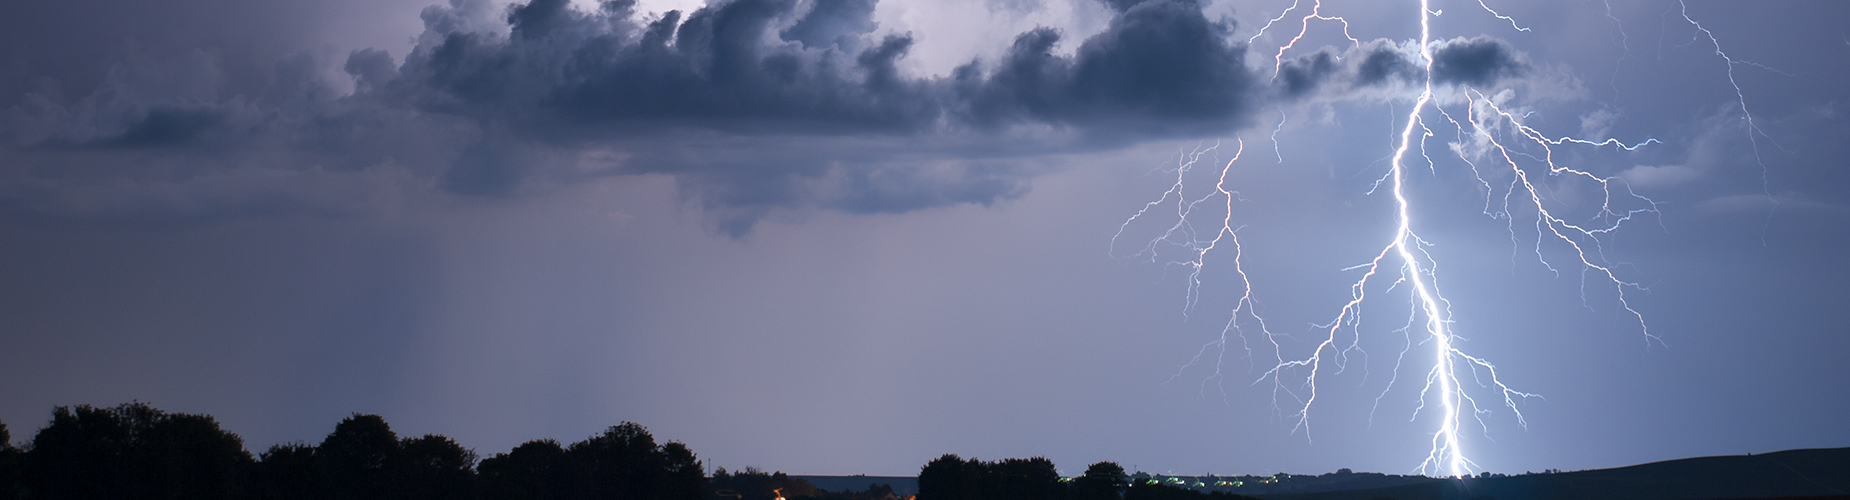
387;0;940;139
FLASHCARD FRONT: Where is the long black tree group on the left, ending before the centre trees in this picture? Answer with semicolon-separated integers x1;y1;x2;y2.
0;402;710;500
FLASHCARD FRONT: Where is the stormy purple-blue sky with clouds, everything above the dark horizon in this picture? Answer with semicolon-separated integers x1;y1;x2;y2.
0;0;1850;474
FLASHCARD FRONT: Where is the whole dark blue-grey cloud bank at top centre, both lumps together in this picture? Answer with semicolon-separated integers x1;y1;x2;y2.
386;0;1252;135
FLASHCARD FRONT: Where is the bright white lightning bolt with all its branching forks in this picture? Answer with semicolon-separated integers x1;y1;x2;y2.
1112;0;1770;476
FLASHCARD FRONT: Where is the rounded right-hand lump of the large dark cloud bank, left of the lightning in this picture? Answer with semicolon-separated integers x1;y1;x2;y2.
955;2;1254;137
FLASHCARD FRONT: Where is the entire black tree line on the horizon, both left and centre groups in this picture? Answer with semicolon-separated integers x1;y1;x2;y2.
0;402;1243;500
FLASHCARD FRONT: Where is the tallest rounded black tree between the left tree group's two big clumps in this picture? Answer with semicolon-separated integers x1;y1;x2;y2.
315;413;400;500
